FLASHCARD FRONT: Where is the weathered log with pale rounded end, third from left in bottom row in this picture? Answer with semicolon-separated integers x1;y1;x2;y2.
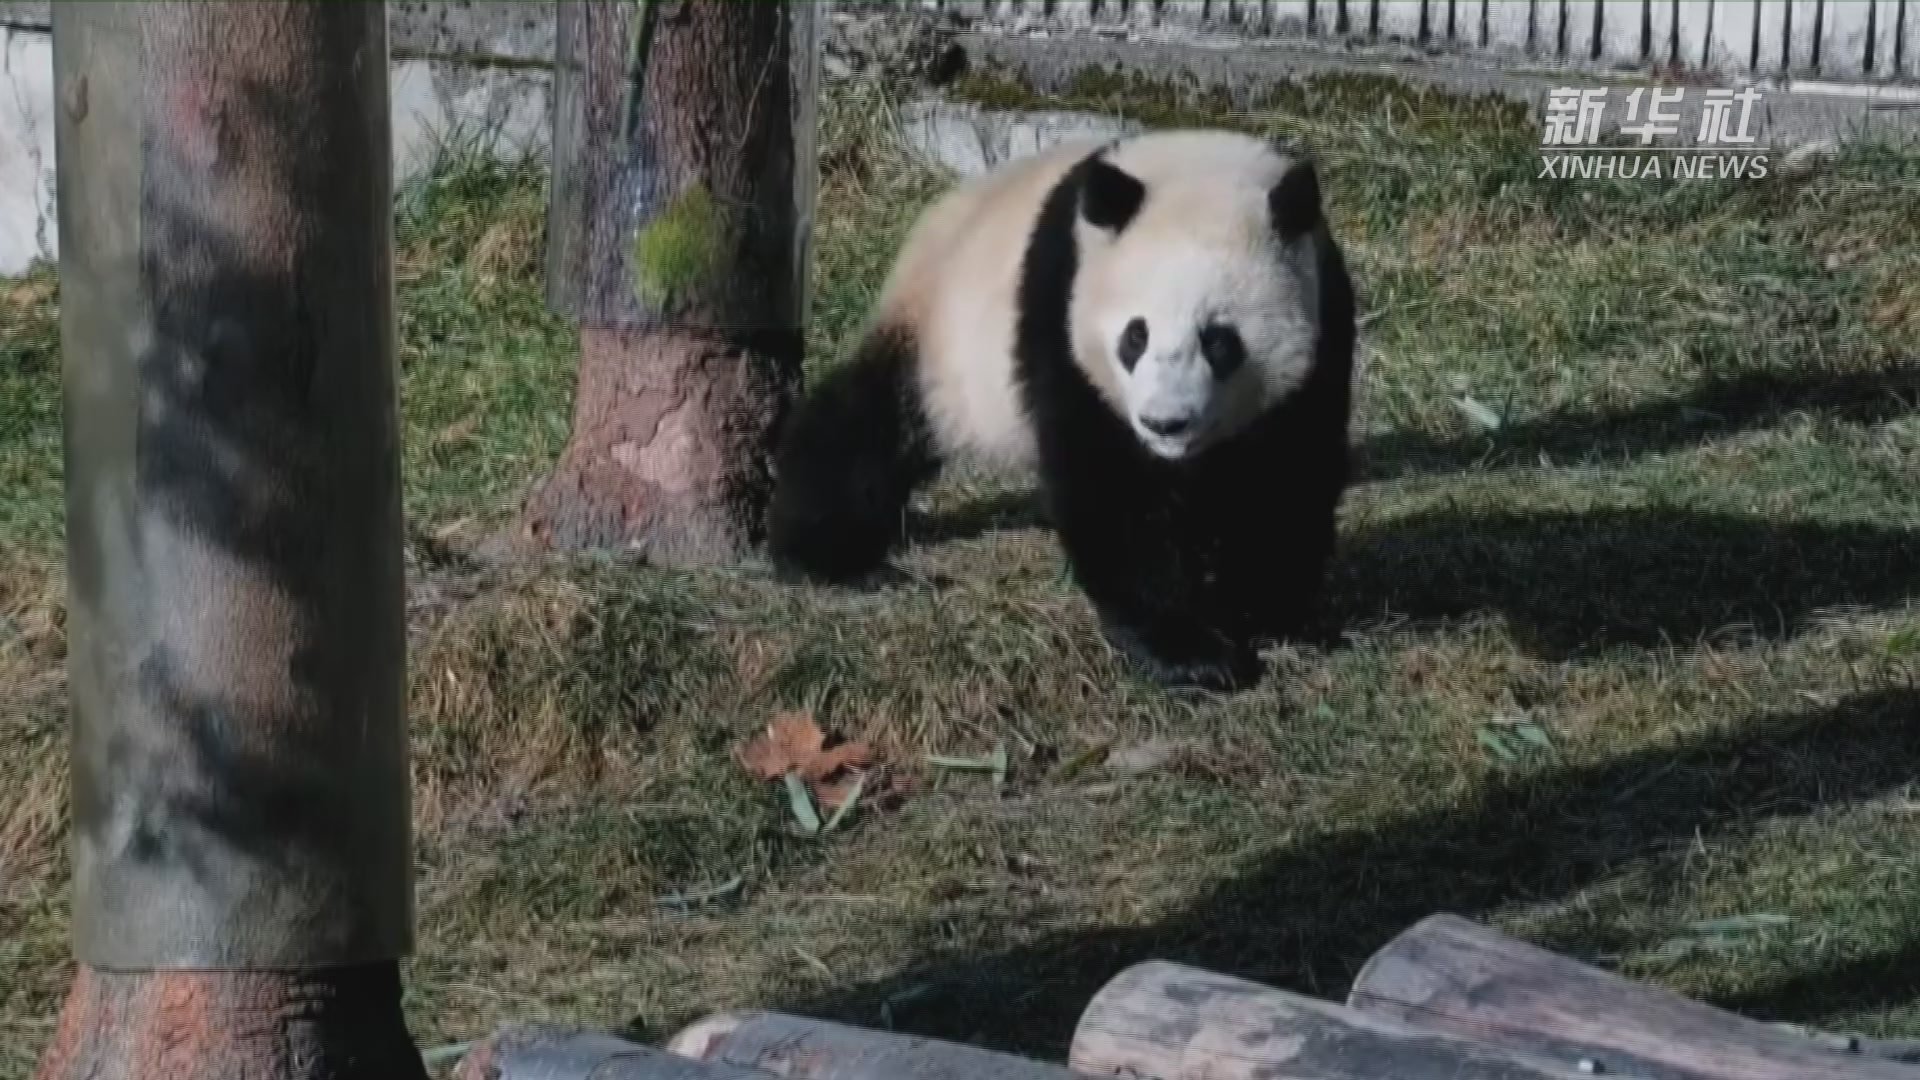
1068;961;1580;1080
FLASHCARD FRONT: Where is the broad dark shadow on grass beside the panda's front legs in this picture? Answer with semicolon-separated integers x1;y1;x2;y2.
1331;509;1920;657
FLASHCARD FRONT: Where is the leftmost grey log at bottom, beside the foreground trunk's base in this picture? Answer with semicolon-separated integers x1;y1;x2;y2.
453;1026;772;1080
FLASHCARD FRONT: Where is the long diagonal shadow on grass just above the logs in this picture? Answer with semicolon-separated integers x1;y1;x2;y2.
770;690;1920;1061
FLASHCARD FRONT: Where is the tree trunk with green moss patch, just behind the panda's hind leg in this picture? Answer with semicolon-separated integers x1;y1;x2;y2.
513;0;814;565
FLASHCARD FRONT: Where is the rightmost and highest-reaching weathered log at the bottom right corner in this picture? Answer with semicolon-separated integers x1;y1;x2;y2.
1348;915;1920;1080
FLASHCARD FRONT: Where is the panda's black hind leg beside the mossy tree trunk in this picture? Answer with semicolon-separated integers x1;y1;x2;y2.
768;329;939;584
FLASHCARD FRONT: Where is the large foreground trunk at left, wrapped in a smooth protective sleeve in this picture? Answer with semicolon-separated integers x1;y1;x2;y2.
40;2;422;1080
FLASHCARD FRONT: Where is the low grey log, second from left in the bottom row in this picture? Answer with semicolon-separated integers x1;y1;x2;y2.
666;1013;1073;1080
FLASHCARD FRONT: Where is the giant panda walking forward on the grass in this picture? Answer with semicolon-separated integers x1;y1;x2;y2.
768;129;1356;690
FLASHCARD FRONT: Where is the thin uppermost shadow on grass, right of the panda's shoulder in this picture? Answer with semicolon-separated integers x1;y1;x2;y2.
1356;365;1920;482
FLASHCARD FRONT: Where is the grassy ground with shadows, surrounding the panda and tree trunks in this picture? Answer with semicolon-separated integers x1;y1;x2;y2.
0;71;1920;1078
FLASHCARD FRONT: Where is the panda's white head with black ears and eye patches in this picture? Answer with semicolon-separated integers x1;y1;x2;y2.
1069;131;1325;461
